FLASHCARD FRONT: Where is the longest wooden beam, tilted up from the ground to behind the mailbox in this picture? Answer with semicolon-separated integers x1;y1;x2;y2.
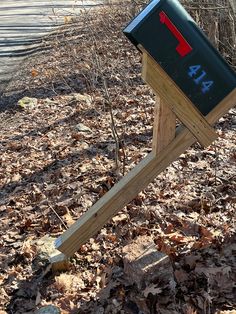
55;89;236;256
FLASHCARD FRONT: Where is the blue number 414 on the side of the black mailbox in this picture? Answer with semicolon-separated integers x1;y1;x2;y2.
188;65;214;94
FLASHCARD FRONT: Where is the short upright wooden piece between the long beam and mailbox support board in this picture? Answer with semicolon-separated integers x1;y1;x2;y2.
152;96;176;155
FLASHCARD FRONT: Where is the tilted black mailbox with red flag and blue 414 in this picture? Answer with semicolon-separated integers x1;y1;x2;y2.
124;0;236;115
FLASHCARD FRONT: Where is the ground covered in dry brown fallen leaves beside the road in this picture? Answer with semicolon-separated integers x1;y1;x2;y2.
0;6;236;314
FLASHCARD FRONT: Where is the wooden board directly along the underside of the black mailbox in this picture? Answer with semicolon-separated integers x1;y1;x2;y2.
141;48;218;146
